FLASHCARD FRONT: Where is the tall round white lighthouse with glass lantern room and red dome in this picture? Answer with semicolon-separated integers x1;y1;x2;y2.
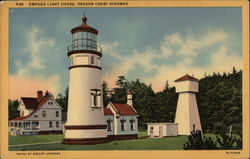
63;16;108;144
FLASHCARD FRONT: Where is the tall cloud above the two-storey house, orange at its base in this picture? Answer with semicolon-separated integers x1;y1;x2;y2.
9;26;61;99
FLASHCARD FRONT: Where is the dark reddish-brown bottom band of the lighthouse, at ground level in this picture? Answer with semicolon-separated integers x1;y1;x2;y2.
62;137;110;145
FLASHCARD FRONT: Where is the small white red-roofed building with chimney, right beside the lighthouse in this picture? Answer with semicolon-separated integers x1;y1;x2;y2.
104;91;139;140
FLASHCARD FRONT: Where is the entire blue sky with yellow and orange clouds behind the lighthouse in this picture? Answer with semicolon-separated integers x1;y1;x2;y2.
9;7;242;99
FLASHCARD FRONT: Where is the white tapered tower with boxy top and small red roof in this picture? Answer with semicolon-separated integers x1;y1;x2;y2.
175;74;202;135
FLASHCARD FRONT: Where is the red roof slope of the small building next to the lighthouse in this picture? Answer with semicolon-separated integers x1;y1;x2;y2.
112;103;138;115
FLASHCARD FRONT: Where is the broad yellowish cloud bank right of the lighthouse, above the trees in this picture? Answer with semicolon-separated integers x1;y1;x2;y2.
104;30;242;91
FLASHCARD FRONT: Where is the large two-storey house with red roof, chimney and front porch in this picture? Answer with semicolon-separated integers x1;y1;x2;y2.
9;91;63;135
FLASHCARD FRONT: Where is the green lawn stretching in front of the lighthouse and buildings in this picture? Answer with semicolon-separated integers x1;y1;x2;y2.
9;132;187;151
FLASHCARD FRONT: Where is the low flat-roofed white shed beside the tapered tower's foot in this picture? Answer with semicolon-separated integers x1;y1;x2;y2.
147;123;178;138
